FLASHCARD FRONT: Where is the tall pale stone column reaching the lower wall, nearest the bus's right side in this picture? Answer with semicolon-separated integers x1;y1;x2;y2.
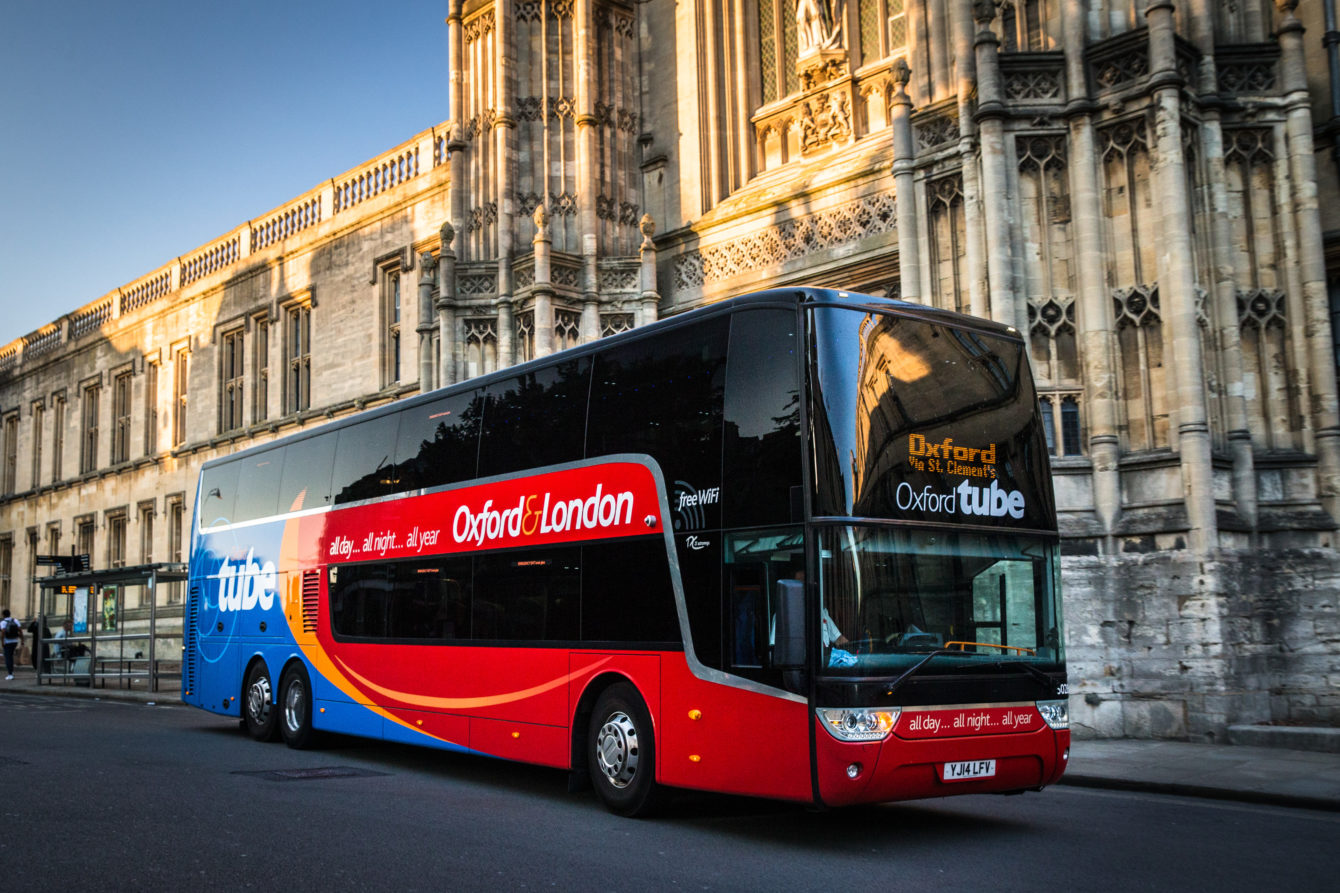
1061;0;1122;539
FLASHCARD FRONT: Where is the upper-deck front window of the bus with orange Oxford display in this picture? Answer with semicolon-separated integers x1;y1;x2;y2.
811;308;1056;530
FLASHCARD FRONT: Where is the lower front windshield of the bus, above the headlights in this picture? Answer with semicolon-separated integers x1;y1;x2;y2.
819;524;1064;677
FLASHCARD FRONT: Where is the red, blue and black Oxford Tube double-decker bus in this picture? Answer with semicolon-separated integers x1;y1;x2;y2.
182;288;1069;815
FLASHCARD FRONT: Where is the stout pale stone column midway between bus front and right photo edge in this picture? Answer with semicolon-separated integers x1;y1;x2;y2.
1144;0;1218;555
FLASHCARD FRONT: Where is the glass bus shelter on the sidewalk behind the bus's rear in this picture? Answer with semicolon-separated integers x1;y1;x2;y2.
32;563;186;692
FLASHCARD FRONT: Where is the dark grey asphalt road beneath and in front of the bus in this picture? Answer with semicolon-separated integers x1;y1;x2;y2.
0;695;1340;893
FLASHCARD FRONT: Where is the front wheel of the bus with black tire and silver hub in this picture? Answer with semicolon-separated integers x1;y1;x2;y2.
587;682;663;817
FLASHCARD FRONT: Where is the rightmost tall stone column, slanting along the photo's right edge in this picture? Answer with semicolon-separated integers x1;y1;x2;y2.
1276;0;1340;518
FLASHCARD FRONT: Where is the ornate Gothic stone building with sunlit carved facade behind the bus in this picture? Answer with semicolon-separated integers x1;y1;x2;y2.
0;0;1340;739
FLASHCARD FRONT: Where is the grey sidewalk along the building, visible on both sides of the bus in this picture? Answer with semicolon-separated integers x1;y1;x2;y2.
0;666;1340;811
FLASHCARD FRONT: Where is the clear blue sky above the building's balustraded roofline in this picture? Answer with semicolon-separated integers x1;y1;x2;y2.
0;0;449;346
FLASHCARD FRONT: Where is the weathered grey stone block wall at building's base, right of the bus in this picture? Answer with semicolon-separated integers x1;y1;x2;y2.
1063;550;1340;741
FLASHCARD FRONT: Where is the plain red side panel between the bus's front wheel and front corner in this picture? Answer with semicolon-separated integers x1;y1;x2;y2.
657;654;813;802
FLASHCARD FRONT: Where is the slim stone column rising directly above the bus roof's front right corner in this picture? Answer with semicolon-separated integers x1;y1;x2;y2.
973;0;1028;333
